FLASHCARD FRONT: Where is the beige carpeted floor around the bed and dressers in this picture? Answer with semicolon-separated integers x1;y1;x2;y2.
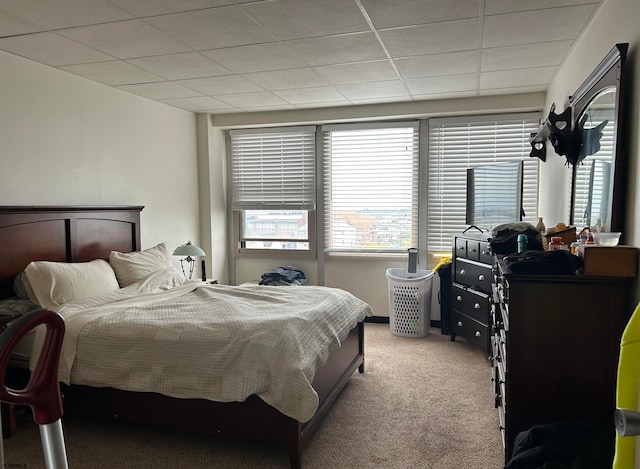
4;323;503;469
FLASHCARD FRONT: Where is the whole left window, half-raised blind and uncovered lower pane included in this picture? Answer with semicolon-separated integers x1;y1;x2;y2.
229;127;316;252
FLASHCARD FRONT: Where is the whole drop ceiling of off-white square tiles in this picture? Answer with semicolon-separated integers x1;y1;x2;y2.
0;0;601;114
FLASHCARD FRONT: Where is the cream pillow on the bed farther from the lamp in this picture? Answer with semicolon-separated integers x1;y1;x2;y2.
24;259;119;311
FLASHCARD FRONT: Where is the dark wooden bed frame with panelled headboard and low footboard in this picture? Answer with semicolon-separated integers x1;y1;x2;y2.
0;206;370;467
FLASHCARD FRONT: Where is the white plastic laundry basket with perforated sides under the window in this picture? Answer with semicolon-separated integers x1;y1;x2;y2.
387;269;435;337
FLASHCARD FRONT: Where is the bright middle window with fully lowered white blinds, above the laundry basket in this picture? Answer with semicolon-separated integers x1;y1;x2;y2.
323;122;419;252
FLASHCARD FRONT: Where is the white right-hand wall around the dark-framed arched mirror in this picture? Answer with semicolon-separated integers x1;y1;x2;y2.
540;0;640;303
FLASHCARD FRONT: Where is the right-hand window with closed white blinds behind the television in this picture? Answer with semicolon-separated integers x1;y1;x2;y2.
427;113;540;262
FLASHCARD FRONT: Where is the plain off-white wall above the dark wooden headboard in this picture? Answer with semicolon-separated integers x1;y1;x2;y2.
0;51;205;274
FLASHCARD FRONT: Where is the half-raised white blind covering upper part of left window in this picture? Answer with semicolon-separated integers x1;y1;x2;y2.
229;126;316;210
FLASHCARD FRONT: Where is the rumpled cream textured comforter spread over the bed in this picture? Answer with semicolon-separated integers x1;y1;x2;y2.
33;268;372;422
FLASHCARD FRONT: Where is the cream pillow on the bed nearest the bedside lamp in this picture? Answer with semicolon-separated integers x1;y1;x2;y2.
109;243;171;287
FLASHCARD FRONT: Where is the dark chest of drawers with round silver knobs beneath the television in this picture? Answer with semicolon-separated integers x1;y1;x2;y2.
451;233;493;356
